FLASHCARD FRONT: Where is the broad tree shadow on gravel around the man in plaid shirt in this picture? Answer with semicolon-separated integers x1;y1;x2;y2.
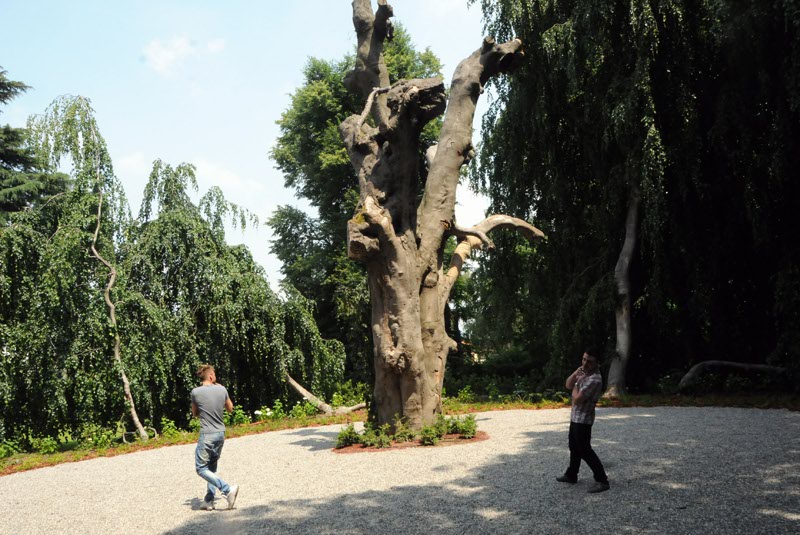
168;409;800;534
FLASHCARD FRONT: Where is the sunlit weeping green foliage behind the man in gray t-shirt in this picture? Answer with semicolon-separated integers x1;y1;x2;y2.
0;93;345;444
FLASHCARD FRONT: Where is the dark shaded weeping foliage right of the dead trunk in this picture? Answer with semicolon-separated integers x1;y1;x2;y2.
467;0;800;388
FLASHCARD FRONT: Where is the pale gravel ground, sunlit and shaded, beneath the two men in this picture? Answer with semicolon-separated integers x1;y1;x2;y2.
0;407;800;534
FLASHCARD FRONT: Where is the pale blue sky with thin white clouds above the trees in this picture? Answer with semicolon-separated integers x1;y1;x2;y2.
0;0;485;288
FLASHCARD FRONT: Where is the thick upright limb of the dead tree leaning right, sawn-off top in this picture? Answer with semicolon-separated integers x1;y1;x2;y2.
417;37;524;278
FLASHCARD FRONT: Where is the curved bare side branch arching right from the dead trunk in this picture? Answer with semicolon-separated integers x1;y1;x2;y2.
441;214;546;301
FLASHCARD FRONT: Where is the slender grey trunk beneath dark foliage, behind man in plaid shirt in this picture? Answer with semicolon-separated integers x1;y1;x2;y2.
604;186;641;398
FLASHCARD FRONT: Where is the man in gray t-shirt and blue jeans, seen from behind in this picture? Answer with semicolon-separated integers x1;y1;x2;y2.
192;364;239;510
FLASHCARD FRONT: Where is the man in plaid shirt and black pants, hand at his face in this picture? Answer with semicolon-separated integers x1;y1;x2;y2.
556;350;610;493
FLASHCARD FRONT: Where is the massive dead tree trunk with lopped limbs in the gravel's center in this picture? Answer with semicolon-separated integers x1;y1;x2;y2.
340;0;544;428
